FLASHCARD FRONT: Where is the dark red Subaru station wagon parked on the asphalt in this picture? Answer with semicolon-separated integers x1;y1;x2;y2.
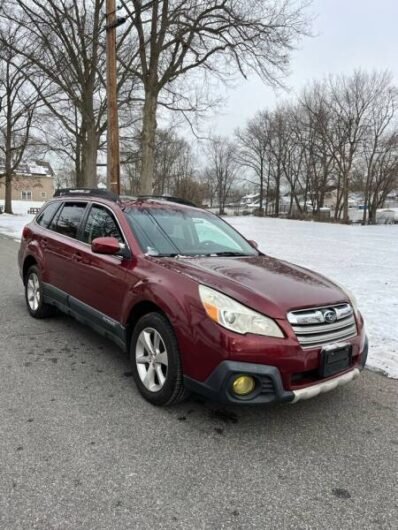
19;189;368;405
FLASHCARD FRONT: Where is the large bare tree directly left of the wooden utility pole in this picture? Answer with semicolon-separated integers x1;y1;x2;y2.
0;0;135;187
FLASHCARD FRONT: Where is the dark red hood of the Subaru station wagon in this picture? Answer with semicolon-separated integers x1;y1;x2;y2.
155;255;349;318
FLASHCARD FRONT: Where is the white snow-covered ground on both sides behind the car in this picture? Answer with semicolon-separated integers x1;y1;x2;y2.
0;201;398;379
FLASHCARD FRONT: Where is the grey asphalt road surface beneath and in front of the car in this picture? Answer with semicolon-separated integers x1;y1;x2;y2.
0;236;398;530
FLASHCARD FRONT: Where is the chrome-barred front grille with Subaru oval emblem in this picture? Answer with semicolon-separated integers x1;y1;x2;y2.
287;304;357;348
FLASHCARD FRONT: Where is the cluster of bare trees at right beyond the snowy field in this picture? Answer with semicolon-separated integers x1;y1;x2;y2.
229;72;398;222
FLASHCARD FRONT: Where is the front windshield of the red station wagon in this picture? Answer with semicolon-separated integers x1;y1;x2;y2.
125;206;258;256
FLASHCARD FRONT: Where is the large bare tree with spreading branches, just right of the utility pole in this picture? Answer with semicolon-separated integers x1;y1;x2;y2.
121;0;307;194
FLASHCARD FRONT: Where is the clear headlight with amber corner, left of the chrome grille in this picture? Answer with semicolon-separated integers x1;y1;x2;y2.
199;285;284;337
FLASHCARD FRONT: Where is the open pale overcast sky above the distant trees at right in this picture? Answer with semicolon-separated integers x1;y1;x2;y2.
211;0;398;135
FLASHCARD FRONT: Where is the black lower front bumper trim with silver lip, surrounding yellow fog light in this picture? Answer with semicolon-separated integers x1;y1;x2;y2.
184;334;368;405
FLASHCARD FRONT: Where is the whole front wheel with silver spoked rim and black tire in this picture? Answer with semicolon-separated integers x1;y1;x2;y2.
130;313;186;406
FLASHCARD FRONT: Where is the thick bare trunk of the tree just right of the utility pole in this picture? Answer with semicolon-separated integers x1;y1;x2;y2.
140;91;157;195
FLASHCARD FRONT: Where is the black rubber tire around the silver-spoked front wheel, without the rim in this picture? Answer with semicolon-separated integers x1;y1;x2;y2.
130;313;188;406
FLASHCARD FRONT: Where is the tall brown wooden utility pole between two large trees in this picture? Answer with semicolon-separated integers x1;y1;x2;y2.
106;0;119;195
